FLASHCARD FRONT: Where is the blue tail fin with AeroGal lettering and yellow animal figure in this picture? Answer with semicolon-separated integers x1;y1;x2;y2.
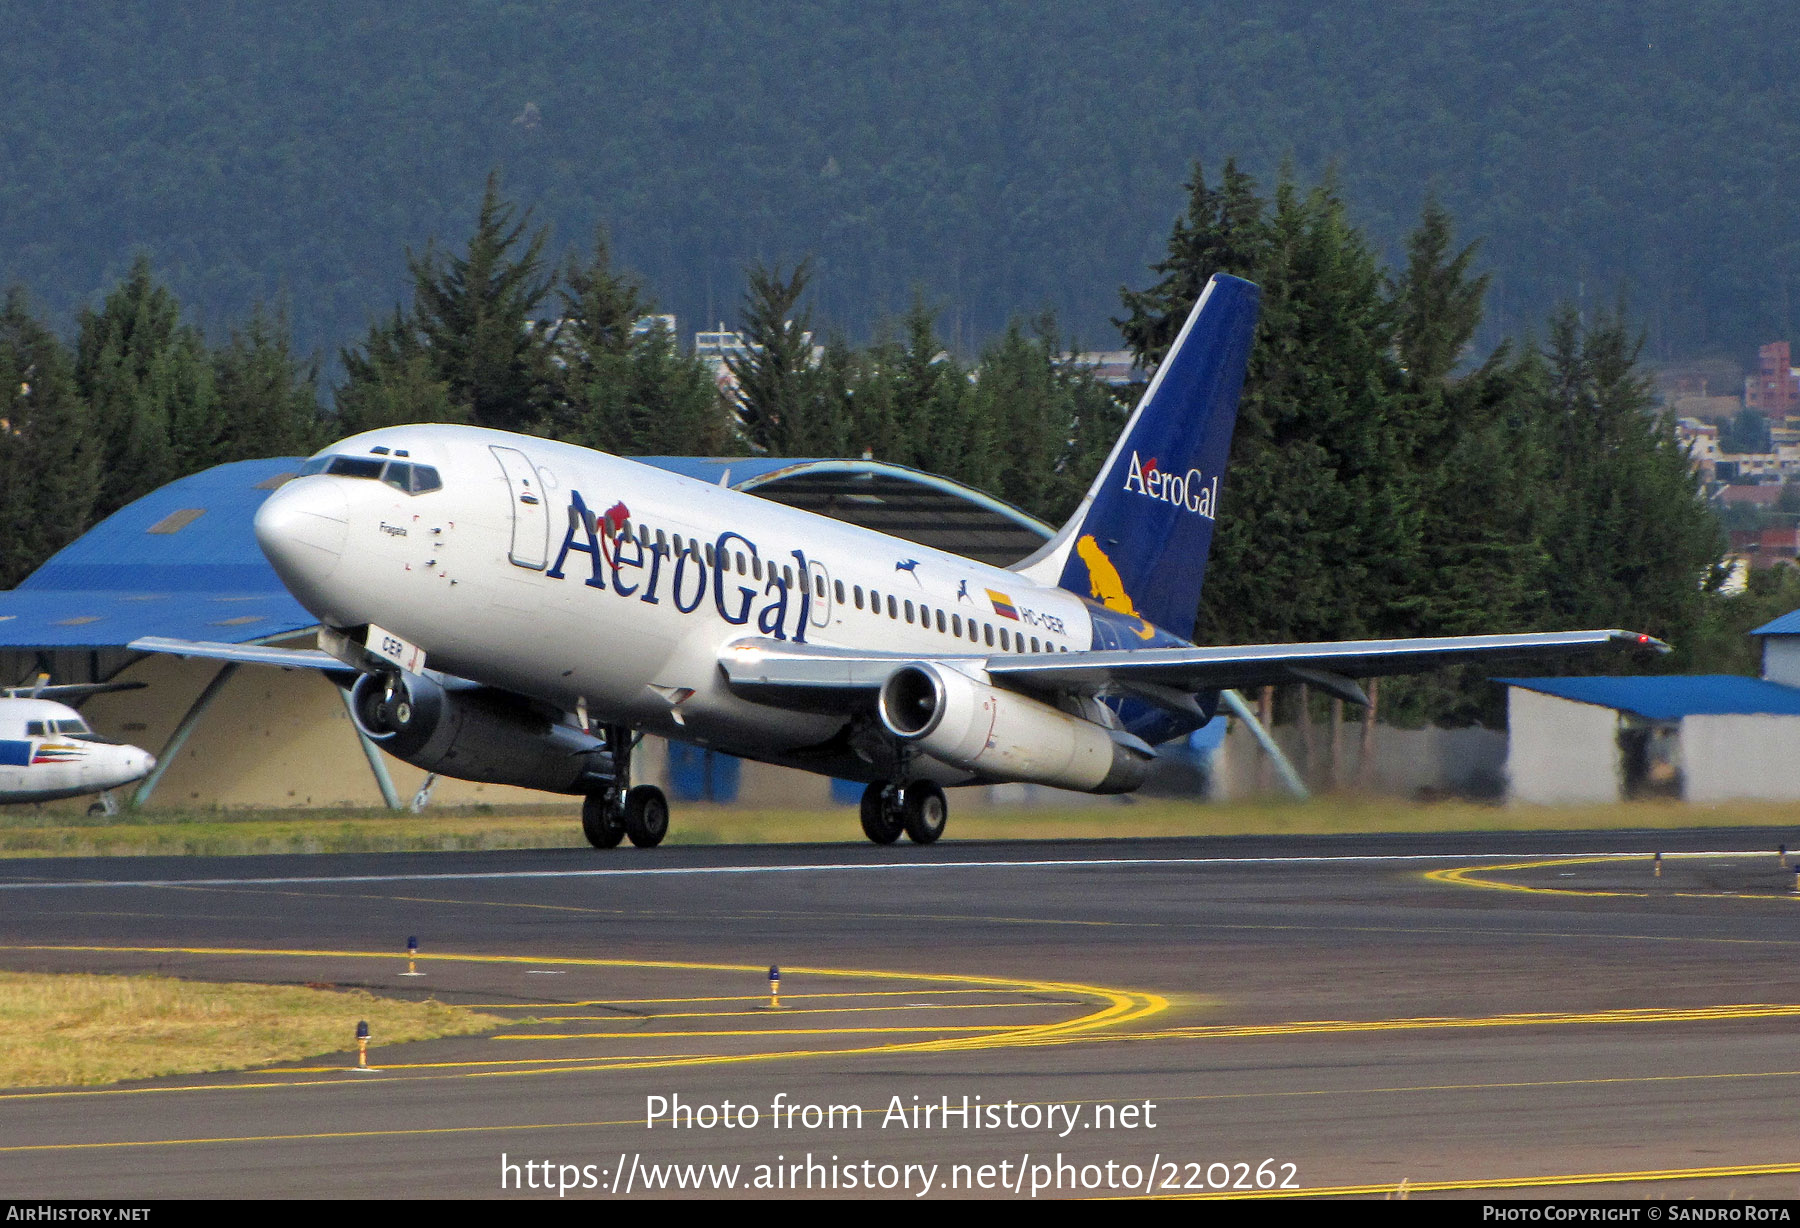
1015;274;1262;639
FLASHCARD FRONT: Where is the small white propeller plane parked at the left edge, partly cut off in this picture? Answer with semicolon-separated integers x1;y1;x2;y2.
0;677;157;812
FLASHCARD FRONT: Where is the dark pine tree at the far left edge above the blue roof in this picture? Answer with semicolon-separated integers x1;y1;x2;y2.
0;288;103;589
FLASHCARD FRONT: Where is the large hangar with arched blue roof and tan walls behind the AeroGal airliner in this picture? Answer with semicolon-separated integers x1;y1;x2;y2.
0;457;1049;807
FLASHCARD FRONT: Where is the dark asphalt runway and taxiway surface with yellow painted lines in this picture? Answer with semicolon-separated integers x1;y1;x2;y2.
0;830;1800;1197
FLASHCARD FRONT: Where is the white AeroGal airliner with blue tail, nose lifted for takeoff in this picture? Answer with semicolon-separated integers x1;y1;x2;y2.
133;275;1661;848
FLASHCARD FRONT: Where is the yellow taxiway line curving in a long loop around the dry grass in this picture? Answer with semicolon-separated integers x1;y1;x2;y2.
0;944;1168;1100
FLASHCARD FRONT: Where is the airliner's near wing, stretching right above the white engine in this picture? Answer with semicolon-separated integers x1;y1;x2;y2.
720;630;1669;711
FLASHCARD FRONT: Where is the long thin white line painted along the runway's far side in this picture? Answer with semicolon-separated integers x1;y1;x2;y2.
0;850;1768;891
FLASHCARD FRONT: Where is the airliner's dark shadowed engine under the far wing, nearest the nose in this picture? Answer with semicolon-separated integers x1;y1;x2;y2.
349;672;612;794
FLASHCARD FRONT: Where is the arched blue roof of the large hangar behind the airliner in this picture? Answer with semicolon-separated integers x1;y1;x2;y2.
0;456;1051;659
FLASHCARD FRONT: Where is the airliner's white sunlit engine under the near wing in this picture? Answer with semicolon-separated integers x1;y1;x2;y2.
877;663;1156;792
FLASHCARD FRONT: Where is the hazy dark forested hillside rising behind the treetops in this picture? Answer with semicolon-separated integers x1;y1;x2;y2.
0;0;1800;357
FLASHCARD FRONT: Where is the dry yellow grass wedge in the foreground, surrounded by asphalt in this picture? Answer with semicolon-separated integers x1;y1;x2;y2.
0;972;517;1088
